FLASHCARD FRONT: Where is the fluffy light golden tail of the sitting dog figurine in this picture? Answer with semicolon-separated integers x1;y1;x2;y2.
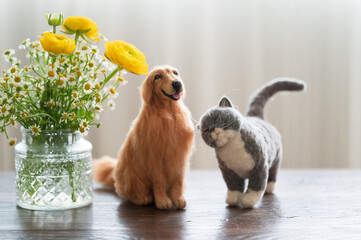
93;156;117;187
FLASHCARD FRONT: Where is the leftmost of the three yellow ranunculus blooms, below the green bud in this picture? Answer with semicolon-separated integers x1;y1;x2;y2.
39;32;75;55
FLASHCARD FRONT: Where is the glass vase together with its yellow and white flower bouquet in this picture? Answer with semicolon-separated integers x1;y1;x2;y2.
0;14;148;210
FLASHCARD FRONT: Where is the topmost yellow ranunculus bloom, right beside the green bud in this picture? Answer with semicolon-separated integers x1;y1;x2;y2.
62;17;100;41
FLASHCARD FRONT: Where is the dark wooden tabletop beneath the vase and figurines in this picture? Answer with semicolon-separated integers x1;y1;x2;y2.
0;170;361;239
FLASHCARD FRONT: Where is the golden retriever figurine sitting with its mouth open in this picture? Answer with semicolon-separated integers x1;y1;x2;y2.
93;66;194;209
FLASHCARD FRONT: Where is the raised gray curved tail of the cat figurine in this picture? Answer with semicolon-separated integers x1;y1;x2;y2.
247;78;306;119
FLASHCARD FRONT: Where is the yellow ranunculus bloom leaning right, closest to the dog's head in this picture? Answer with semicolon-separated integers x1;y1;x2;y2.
104;40;148;75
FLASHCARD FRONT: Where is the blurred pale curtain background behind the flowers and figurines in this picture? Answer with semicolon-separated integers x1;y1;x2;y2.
0;0;361;170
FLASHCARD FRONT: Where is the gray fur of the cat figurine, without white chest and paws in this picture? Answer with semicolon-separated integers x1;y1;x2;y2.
200;79;305;206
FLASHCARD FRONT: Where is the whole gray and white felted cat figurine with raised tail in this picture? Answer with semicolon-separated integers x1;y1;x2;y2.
199;78;306;208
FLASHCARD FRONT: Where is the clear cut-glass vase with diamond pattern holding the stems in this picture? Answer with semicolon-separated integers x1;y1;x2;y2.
15;128;93;210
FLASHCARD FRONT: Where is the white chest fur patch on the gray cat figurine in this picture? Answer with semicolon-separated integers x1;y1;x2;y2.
216;130;255;178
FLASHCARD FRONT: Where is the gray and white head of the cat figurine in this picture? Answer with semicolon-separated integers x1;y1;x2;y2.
198;97;241;148
